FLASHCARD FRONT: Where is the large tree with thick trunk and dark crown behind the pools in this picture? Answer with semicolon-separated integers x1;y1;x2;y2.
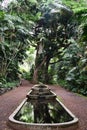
33;1;74;83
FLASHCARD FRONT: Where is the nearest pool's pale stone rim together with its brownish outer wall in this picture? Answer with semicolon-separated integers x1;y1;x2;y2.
8;91;78;130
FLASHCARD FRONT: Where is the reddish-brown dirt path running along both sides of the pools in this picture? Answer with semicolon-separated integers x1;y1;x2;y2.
0;81;87;130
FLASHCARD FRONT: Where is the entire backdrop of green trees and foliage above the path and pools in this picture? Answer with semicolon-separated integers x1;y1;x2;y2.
0;0;87;96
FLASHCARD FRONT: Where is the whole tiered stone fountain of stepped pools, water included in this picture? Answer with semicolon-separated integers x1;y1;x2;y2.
9;84;78;130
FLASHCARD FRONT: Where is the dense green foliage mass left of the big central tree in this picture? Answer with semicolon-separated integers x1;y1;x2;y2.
0;2;34;82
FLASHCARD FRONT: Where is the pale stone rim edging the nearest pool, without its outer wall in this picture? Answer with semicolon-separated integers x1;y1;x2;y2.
9;92;78;127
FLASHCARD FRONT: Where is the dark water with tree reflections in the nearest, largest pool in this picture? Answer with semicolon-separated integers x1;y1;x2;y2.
15;100;72;123
